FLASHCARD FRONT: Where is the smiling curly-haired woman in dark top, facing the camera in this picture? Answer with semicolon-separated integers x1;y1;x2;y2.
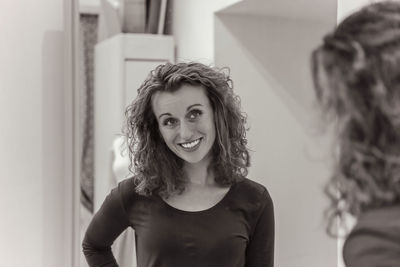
83;63;274;267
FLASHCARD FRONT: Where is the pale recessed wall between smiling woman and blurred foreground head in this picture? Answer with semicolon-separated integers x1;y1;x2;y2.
215;14;337;267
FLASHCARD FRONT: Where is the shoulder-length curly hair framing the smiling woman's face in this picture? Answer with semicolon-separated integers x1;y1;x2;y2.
123;62;250;197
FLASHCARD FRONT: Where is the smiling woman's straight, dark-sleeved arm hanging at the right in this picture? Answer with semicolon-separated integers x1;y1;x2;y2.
246;191;275;267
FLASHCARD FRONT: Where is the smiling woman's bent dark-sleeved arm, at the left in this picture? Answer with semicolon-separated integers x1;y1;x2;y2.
82;184;129;267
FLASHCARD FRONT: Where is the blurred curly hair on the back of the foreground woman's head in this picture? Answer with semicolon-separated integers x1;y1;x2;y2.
311;1;400;235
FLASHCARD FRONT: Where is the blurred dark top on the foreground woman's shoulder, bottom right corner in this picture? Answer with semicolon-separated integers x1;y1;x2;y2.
343;205;400;267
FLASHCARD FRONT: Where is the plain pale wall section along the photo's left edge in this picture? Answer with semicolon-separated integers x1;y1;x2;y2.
0;0;70;267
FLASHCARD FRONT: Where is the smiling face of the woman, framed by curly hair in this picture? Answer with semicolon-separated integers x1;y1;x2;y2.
151;85;215;163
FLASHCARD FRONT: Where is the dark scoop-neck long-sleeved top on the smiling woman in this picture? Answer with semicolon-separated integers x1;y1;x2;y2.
83;179;274;267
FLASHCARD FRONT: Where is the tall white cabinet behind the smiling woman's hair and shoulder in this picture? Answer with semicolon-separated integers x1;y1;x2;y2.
94;34;174;211
